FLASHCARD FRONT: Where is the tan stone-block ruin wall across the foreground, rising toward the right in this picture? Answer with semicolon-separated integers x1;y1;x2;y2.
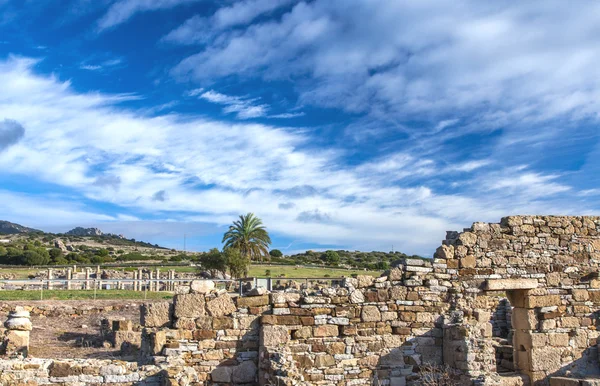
0;216;600;386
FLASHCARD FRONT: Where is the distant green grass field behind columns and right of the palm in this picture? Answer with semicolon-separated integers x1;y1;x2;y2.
0;264;381;279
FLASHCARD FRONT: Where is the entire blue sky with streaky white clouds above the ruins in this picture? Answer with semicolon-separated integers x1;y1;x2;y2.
0;0;600;256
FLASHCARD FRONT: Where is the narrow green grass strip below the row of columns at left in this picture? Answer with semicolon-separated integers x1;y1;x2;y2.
0;290;173;300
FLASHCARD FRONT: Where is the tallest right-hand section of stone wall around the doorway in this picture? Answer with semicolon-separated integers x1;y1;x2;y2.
435;216;600;384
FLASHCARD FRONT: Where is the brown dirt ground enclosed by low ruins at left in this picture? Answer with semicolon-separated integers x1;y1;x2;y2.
1;300;164;359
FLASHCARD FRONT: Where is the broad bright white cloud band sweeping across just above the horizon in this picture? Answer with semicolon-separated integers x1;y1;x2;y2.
0;58;595;254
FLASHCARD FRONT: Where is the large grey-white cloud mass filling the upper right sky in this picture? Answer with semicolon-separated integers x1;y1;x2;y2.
174;0;600;137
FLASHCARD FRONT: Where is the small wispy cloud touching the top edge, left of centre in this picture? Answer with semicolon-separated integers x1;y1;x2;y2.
98;0;200;31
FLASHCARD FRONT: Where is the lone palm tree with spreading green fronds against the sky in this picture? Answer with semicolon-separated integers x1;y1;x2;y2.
222;213;271;261
